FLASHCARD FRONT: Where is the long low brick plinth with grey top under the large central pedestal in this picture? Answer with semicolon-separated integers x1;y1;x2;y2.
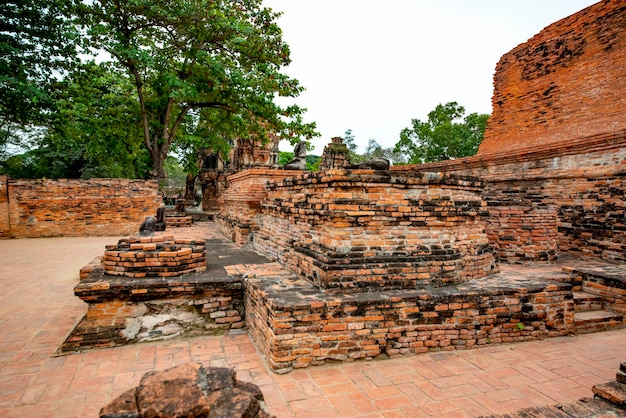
244;262;574;373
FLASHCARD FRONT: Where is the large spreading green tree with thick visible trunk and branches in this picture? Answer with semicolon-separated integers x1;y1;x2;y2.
79;0;316;178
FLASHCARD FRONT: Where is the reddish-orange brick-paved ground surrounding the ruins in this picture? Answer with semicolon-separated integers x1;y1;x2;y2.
0;227;626;418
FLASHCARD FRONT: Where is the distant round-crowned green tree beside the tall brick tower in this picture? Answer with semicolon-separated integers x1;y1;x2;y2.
395;102;489;164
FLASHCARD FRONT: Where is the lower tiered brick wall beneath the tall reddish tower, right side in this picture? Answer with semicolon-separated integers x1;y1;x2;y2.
402;131;626;263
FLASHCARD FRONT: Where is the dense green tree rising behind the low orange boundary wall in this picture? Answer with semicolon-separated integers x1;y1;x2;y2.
0;62;150;178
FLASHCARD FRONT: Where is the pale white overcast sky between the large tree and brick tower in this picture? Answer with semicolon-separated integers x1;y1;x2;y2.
263;0;596;155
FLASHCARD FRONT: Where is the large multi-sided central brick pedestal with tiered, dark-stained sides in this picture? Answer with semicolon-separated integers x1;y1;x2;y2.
254;170;495;292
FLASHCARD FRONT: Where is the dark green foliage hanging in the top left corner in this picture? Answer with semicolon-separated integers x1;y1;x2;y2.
0;0;78;158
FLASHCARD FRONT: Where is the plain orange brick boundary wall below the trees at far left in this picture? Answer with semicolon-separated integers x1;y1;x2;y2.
0;179;161;238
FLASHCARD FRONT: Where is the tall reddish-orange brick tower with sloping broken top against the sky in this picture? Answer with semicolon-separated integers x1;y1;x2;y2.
478;0;626;155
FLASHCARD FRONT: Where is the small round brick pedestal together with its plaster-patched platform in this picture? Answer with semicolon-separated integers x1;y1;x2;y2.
58;235;251;353
